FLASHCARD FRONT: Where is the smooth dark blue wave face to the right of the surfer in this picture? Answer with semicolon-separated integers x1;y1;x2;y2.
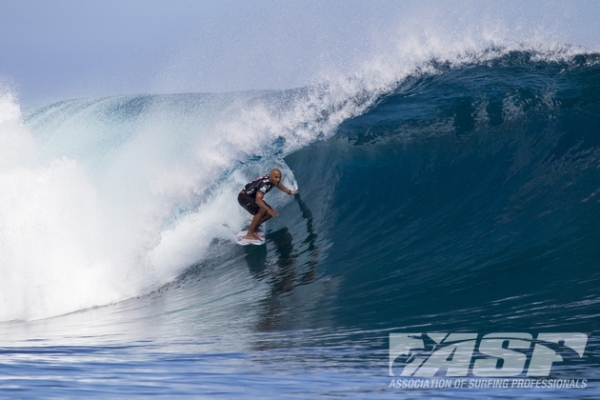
286;52;600;333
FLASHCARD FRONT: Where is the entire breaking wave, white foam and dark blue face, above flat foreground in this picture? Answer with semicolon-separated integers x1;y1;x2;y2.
0;49;600;330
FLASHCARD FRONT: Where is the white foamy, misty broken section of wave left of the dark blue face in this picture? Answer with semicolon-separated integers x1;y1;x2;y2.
0;82;390;321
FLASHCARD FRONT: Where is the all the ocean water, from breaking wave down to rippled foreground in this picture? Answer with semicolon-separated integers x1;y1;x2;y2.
0;45;600;399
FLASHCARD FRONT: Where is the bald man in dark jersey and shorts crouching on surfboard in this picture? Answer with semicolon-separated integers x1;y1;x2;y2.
238;168;298;240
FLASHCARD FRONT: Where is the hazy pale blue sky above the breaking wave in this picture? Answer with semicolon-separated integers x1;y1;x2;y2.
0;0;600;105
